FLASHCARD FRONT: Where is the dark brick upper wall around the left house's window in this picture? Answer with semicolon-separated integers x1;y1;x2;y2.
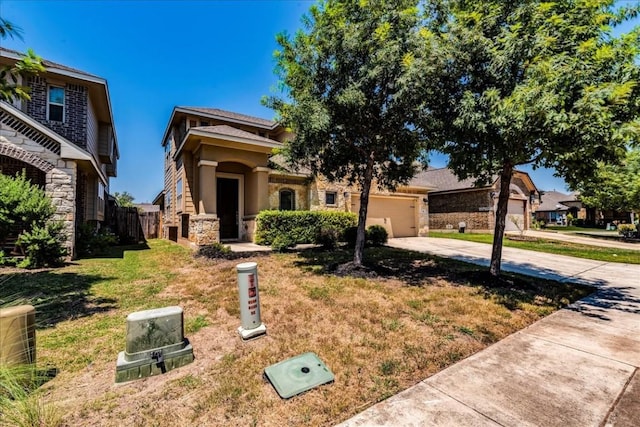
26;76;88;149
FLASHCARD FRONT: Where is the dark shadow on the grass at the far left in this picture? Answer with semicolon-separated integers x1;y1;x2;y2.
0;270;117;329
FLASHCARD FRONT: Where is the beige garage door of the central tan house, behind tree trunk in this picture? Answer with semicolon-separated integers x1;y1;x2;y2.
351;196;418;237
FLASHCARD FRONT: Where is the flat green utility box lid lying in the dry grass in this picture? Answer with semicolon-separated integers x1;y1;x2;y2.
264;352;334;399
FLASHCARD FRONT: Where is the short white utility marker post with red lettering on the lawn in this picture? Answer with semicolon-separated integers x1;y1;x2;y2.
236;262;267;340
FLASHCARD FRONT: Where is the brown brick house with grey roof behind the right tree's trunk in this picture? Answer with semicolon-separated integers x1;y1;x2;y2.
413;168;539;232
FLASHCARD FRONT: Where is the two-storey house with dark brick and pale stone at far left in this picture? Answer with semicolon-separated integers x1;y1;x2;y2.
0;48;119;256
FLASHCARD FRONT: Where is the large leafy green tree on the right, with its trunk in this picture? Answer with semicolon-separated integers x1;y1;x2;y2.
416;0;640;276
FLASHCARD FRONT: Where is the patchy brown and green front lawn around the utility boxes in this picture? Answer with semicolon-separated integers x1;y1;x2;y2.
0;240;591;426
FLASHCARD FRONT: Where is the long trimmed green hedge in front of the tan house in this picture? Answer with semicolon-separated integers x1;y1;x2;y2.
255;211;357;250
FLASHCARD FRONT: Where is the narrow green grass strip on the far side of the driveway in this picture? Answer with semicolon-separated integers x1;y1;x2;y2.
429;232;640;264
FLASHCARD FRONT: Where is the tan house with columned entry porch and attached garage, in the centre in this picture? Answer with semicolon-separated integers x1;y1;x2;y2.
154;107;430;245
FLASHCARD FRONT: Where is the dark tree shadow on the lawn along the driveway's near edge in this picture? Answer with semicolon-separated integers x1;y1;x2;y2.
296;247;594;310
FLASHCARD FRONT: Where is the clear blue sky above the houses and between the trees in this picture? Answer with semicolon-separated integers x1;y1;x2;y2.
0;0;636;202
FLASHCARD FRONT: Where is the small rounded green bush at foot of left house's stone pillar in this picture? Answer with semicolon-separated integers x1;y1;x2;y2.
17;222;67;268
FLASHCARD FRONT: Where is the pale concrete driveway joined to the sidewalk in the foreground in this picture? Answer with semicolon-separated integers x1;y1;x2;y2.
341;237;640;427
